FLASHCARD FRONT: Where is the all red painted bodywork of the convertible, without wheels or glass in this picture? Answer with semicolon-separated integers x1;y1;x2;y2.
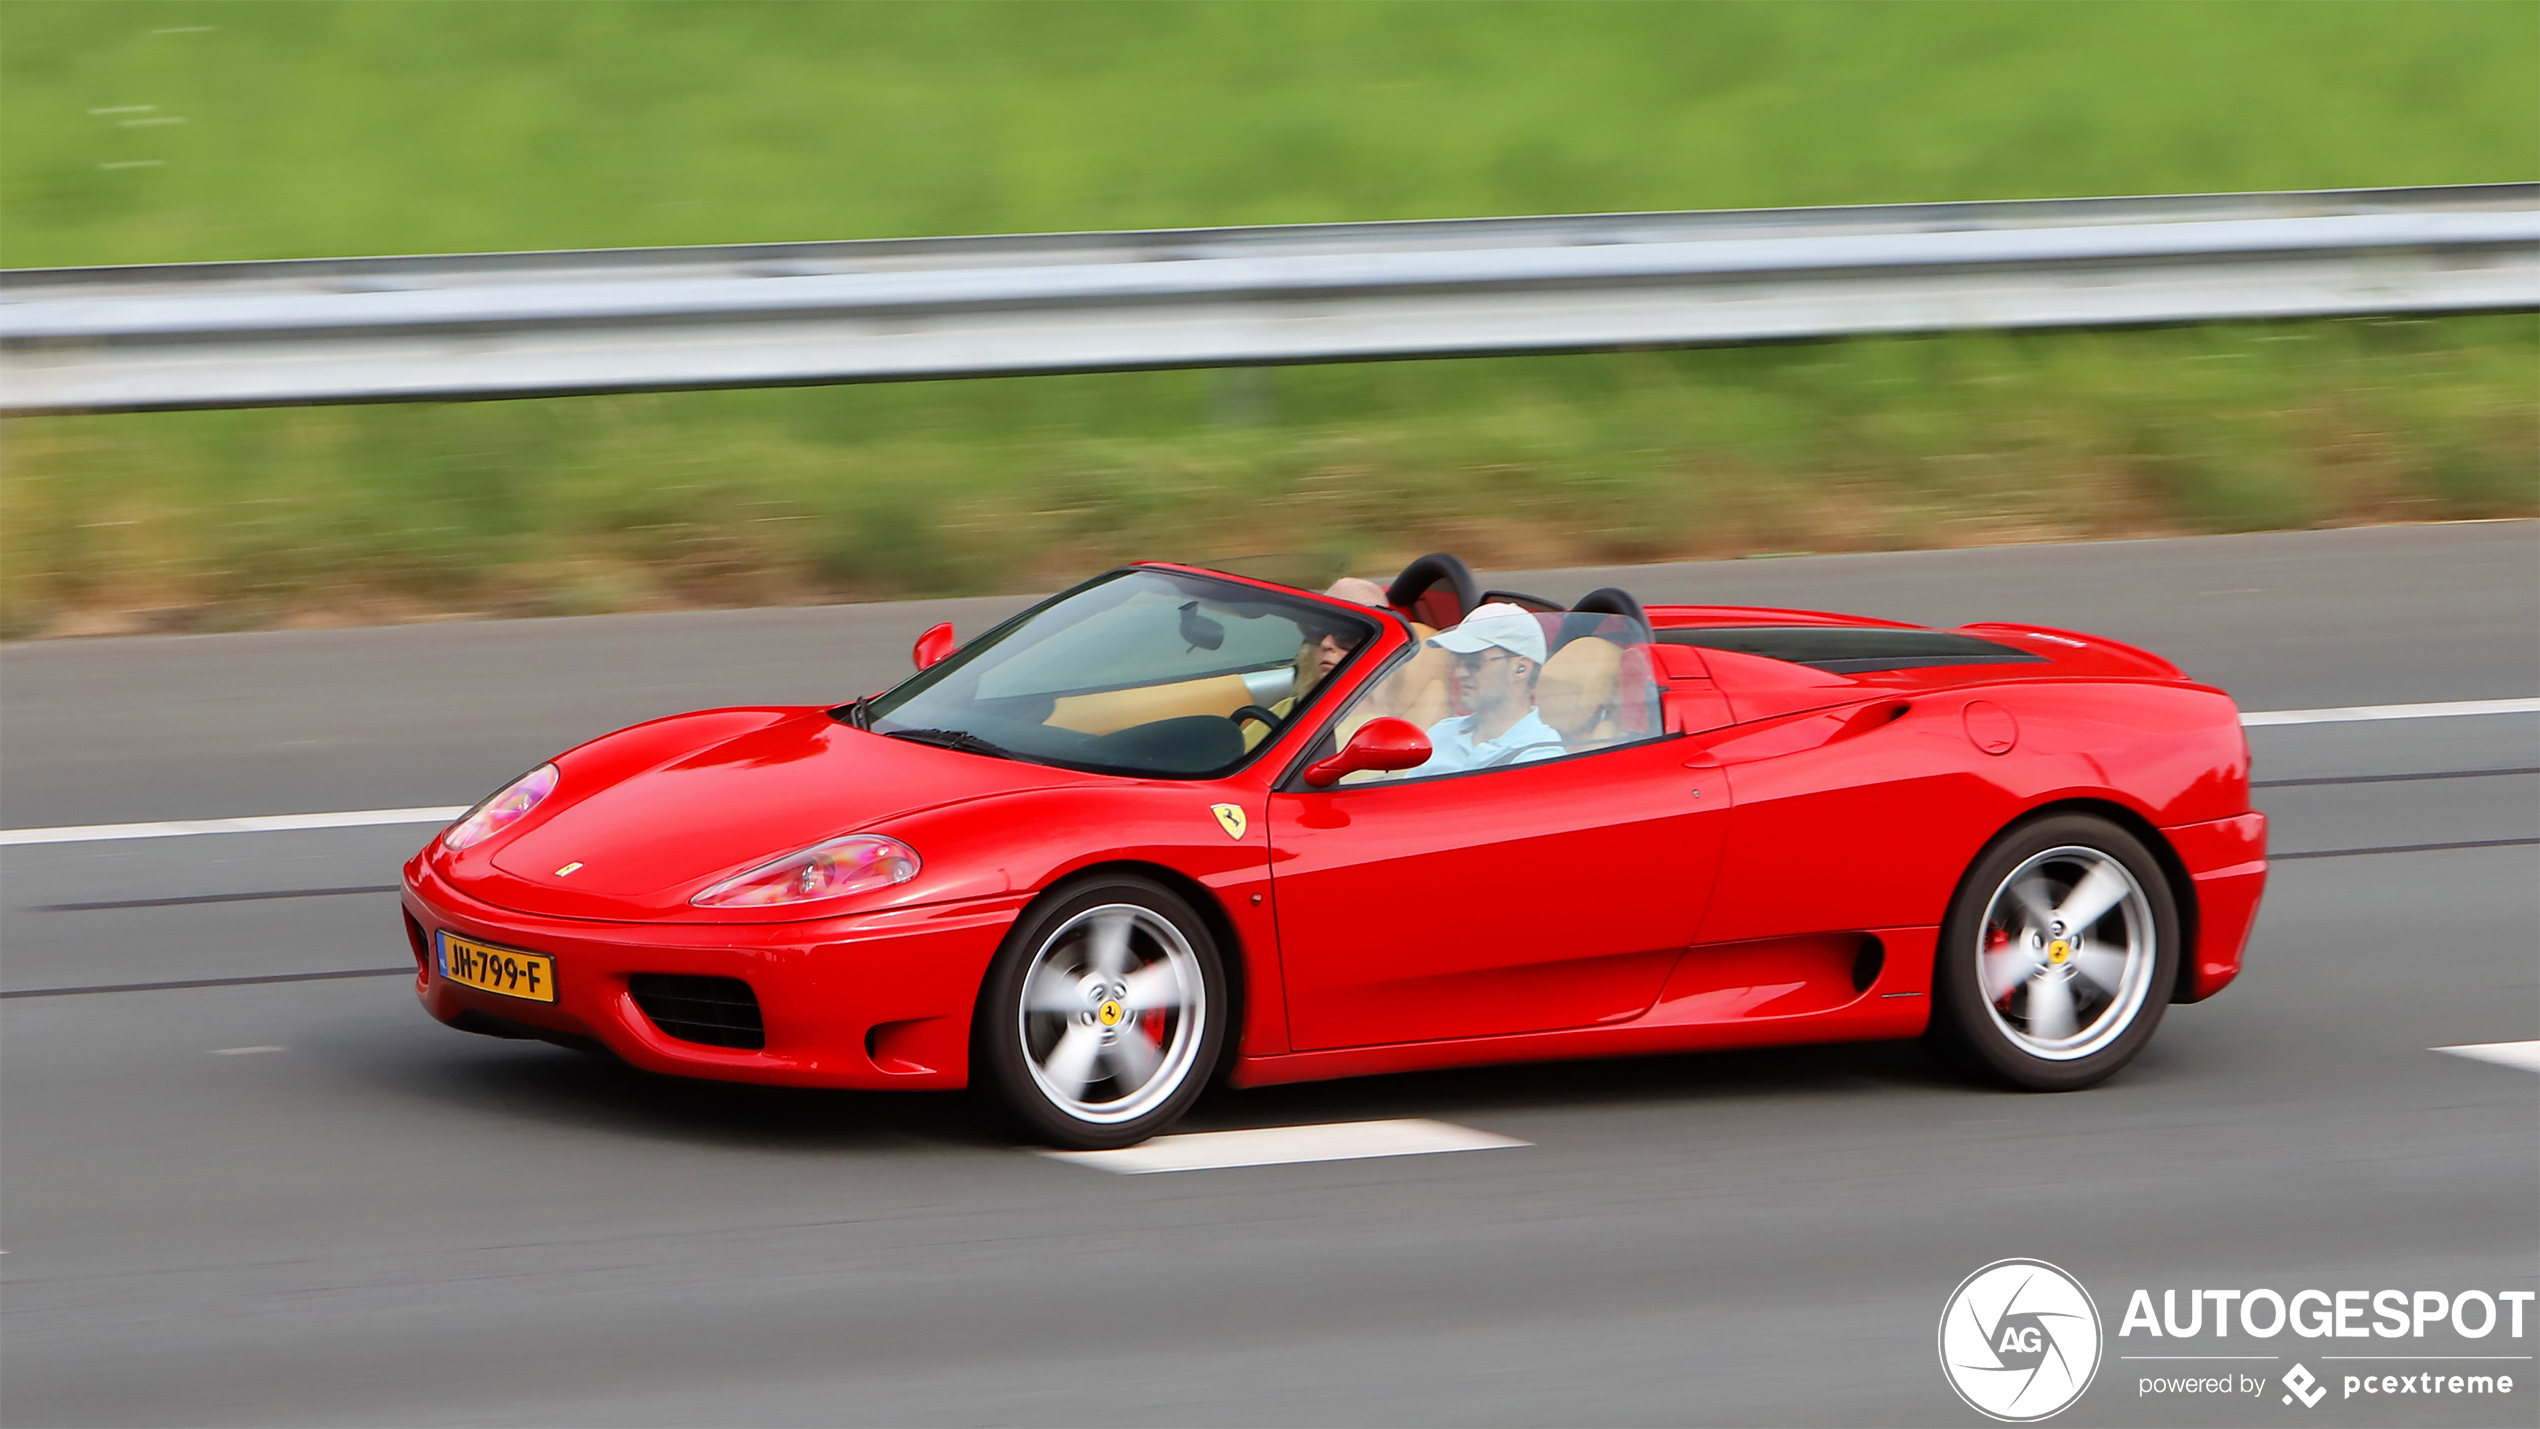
404;566;2266;1086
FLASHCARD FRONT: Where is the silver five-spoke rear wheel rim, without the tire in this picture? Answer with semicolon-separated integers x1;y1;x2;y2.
1976;845;2159;1061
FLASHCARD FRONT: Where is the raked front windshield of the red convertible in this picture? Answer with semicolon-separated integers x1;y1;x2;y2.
864;571;1377;777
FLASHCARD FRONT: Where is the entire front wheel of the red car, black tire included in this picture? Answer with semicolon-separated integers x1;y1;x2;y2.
973;876;1234;1150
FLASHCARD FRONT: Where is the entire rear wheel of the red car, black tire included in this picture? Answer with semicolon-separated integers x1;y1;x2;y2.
1930;815;2182;1091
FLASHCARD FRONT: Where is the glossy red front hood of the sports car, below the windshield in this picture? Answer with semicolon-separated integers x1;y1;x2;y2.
467;713;1095;921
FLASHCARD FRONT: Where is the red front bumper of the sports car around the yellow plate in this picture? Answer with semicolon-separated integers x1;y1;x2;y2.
404;858;1026;1089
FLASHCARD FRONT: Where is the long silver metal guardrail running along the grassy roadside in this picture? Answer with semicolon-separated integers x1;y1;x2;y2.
0;183;2540;414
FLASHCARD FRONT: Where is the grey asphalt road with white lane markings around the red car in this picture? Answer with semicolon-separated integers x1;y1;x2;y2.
0;523;2540;1424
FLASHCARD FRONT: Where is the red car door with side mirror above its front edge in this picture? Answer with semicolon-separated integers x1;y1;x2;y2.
1267;642;1727;1051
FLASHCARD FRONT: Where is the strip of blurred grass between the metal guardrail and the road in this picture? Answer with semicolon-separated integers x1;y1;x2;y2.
0;317;2540;635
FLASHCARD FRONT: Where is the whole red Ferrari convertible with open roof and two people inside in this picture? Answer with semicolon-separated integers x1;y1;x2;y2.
404;556;2266;1147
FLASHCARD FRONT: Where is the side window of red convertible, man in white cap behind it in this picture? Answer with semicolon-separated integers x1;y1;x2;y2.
1316;612;1664;784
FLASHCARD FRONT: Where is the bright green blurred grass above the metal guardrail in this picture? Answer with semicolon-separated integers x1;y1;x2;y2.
0;0;2540;267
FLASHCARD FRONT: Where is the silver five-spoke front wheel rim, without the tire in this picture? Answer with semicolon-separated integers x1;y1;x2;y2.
1016;904;1209;1124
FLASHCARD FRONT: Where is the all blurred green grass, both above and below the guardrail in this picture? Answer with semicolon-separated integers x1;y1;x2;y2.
0;0;2540;637
